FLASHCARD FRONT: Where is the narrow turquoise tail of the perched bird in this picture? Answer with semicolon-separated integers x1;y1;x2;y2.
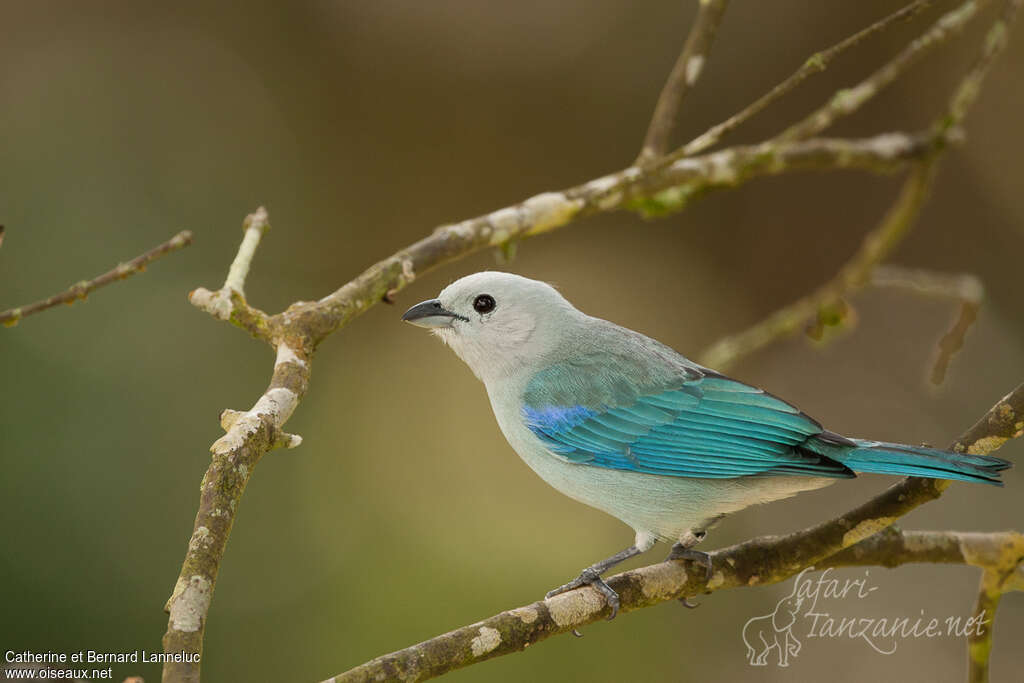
823;438;1011;486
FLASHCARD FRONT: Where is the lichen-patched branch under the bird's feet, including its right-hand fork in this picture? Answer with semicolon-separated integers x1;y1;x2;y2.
328;384;1024;683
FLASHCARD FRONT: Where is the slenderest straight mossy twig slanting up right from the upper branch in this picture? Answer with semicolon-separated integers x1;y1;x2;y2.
671;0;932;159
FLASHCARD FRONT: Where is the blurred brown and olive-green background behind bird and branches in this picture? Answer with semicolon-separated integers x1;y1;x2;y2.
0;0;1024;681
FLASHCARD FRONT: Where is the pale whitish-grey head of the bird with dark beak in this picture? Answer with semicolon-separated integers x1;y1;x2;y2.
401;270;582;382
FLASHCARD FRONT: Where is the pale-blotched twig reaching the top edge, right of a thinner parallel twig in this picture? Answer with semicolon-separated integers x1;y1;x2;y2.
776;0;987;140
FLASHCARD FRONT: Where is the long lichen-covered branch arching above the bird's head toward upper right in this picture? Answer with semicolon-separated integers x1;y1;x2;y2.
284;133;941;345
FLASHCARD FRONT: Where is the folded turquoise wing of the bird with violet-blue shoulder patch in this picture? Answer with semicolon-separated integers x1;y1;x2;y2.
522;356;854;478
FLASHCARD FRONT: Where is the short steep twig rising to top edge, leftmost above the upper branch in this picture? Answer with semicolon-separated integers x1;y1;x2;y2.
636;0;729;166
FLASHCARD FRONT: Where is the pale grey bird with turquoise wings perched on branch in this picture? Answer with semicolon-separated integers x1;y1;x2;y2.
401;271;1010;620
